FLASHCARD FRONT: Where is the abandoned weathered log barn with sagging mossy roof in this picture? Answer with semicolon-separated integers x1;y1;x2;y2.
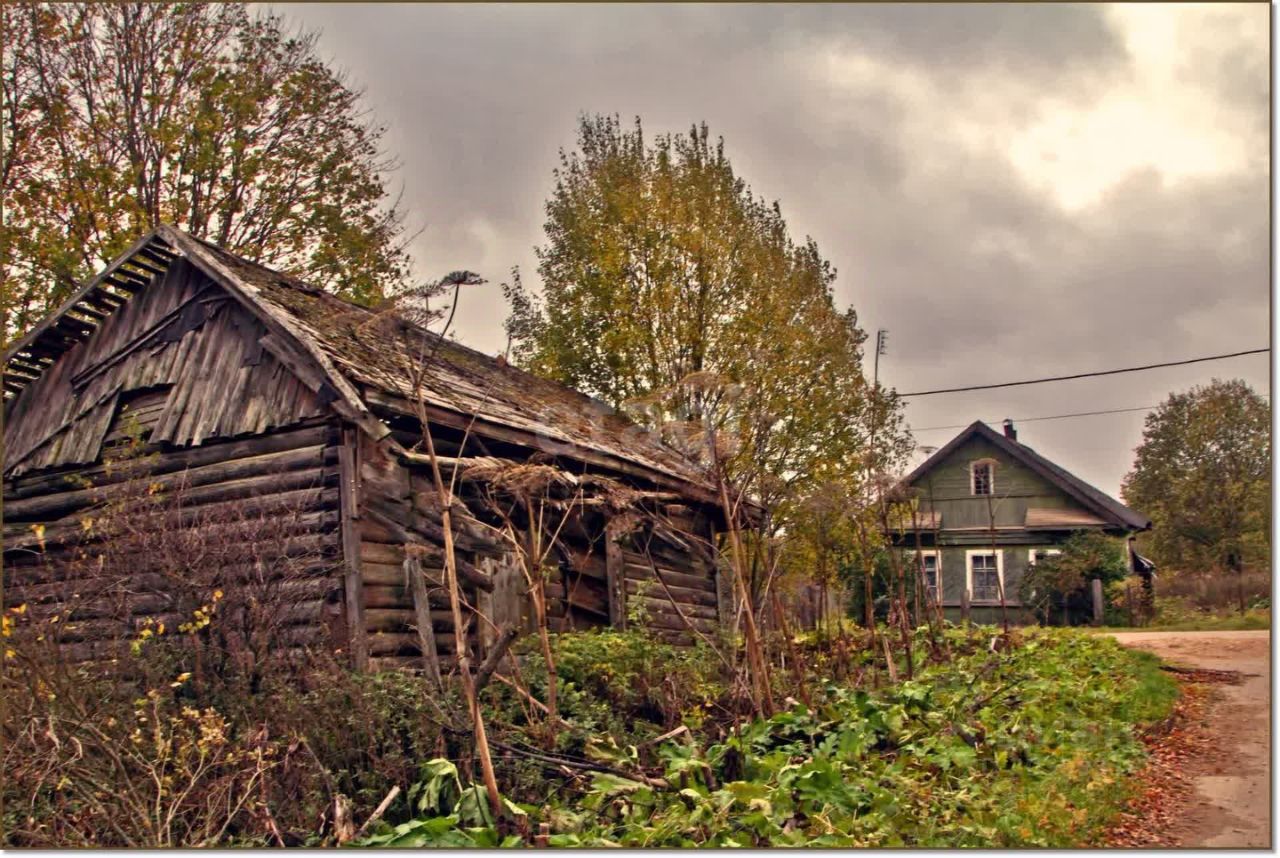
4;227;732;670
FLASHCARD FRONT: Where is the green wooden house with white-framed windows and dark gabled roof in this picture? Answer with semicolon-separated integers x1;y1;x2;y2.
890;420;1151;622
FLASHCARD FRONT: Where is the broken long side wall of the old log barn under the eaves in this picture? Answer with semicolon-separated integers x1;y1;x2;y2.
352;430;731;670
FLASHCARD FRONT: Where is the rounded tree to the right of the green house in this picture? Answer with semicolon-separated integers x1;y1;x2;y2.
1121;379;1271;581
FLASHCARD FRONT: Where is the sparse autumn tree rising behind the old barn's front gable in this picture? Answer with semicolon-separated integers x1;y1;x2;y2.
0;3;408;339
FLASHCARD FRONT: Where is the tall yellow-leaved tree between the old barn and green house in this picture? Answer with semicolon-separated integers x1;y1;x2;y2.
507;117;904;525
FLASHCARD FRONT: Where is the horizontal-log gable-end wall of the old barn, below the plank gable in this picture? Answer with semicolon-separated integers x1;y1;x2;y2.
4;420;348;661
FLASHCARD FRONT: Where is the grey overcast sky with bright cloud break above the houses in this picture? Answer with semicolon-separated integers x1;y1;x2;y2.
278;4;1270;494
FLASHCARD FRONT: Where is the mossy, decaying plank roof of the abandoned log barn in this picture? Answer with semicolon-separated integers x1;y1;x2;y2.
4;225;710;496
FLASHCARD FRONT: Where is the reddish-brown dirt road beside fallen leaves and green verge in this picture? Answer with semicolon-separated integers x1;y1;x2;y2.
1114;631;1271;849
